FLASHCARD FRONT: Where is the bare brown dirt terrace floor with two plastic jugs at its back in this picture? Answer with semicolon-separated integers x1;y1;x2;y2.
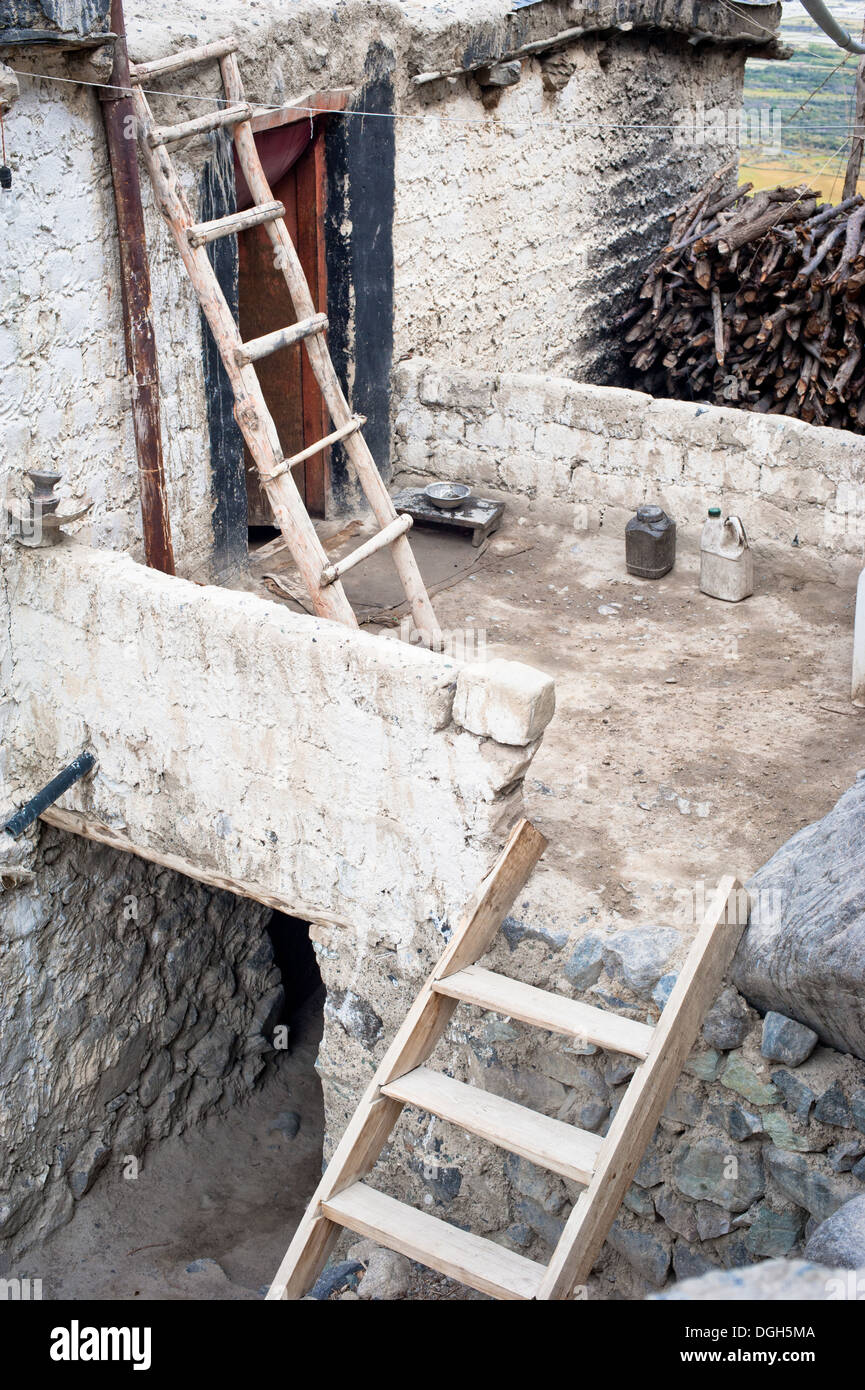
425;500;865;926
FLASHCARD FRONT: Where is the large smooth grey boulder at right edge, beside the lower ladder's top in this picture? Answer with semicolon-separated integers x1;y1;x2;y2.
733;771;865;1058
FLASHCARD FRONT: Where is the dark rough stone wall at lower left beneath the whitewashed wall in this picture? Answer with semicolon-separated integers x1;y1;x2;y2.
0;828;282;1273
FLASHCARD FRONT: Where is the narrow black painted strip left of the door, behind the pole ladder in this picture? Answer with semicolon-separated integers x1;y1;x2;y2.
200;135;248;578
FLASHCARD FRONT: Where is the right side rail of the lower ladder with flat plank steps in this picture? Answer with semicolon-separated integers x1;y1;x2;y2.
537;876;748;1300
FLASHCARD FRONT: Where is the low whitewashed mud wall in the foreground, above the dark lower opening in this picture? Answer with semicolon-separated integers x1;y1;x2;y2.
1;545;552;922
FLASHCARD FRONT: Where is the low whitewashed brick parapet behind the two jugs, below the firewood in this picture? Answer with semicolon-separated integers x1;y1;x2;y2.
394;360;865;575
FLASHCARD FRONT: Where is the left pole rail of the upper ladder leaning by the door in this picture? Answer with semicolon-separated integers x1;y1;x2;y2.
132;86;357;627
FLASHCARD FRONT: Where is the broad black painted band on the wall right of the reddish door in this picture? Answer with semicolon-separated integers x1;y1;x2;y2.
325;56;396;509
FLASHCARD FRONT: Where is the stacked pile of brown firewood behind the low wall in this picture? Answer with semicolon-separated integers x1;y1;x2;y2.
620;177;865;432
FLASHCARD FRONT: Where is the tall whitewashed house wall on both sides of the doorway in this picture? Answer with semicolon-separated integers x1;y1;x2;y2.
0;0;777;577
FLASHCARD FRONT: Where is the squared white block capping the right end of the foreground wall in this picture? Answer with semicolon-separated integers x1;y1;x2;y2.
453;657;556;746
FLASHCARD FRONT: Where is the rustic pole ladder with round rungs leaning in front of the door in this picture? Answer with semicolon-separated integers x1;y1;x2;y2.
131;39;441;648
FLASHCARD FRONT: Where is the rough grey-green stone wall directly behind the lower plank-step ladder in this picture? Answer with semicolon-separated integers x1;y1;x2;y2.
313;872;865;1300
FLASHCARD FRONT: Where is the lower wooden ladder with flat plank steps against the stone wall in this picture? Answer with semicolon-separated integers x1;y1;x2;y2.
267;820;748;1300
